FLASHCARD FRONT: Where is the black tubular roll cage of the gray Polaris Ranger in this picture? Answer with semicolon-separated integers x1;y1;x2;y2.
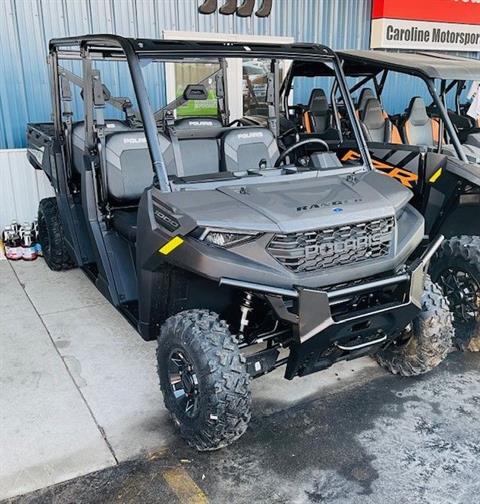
49;34;371;192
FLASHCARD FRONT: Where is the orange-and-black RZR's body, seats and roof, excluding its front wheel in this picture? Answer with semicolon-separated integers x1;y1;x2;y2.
282;50;480;237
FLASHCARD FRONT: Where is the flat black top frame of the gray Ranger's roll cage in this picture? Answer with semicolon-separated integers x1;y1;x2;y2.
49;34;335;59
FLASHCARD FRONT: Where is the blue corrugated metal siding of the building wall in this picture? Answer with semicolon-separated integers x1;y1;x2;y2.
0;0;478;148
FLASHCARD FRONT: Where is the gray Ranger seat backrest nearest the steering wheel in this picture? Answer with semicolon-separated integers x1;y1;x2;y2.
222;127;280;172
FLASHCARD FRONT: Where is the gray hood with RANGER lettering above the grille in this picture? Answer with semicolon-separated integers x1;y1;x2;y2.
158;171;412;233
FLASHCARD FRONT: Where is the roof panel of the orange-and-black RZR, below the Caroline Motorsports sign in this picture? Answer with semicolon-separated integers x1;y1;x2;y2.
338;50;480;81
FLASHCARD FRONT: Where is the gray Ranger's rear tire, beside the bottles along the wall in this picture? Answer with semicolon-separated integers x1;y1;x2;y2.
38;198;75;271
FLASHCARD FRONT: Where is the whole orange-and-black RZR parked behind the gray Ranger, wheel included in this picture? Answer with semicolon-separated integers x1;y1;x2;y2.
283;51;480;350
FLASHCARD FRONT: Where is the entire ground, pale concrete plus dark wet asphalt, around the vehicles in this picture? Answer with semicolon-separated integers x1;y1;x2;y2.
0;259;480;503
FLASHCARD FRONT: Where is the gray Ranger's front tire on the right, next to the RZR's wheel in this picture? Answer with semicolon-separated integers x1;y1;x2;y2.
375;276;454;376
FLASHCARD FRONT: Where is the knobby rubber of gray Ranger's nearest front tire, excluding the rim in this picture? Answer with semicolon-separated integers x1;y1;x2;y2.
157;310;251;451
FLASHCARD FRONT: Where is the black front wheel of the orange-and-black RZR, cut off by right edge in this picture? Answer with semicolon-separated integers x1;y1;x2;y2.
430;236;480;352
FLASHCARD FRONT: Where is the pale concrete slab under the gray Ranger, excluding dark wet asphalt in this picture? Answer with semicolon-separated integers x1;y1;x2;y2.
0;259;384;502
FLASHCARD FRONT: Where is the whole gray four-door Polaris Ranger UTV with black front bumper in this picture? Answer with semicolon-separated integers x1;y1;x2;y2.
28;35;452;450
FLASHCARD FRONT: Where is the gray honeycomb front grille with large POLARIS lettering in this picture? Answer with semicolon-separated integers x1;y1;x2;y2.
267;217;395;273
